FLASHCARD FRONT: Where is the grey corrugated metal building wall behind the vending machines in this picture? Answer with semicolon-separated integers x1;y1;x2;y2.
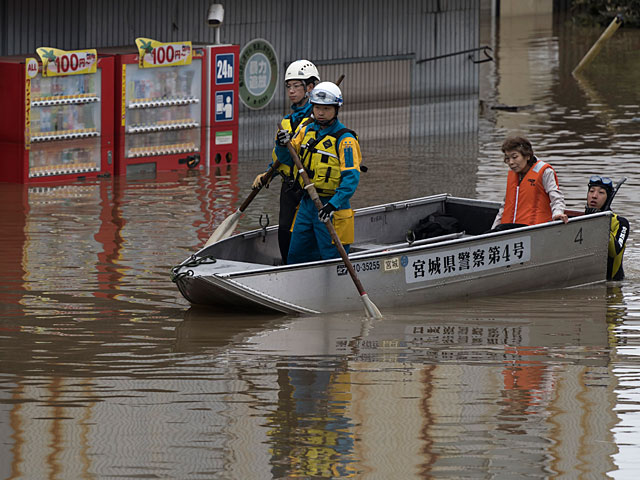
0;0;480;150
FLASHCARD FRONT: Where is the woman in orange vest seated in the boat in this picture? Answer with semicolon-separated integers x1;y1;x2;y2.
491;137;569;231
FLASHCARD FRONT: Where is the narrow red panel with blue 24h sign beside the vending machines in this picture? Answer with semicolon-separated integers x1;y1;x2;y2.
205;45;240;166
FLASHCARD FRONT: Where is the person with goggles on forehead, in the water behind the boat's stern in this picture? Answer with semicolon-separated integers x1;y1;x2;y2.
584;175;629;280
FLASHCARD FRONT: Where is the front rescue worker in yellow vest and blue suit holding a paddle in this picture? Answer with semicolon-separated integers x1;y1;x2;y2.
275;82;362;264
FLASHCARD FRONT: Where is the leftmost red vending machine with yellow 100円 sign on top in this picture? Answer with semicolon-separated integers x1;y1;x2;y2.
0;47;114;183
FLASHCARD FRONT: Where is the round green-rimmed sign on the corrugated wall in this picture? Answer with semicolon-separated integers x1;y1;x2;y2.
238;38;278;110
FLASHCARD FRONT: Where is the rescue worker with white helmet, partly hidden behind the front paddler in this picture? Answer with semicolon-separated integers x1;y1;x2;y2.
252;60;320;264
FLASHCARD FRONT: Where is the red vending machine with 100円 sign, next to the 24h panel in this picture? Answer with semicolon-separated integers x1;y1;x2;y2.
110;38;206;175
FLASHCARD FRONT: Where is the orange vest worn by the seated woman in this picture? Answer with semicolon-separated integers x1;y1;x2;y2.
500;160;558;225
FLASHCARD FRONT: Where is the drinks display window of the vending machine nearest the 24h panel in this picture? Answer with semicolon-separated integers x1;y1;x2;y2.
123;59;202;159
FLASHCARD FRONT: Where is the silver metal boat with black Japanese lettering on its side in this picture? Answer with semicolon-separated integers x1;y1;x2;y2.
175;196;609;313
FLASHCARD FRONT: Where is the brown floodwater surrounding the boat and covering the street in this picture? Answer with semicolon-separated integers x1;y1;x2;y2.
0;11;640;479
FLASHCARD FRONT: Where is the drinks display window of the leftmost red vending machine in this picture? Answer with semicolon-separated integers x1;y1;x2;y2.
29;74;102;178
